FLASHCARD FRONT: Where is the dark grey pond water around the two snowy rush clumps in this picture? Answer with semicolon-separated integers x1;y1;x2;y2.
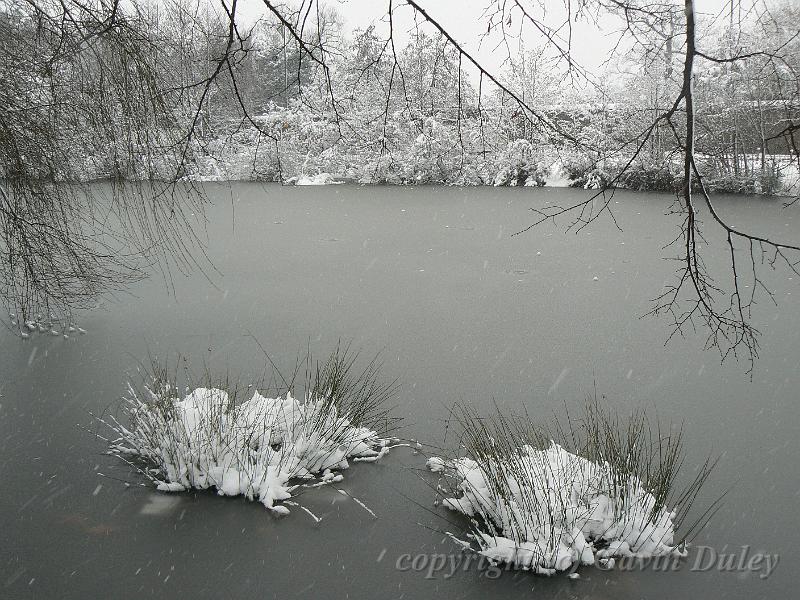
0;184;800;598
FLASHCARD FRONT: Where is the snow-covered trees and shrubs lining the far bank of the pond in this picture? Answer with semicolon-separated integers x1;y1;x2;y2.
0;1;800;193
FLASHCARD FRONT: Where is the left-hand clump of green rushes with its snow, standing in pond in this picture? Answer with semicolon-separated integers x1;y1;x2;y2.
101;347;397;518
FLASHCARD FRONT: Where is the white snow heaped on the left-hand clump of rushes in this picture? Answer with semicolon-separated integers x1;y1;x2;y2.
108;388;388;515
